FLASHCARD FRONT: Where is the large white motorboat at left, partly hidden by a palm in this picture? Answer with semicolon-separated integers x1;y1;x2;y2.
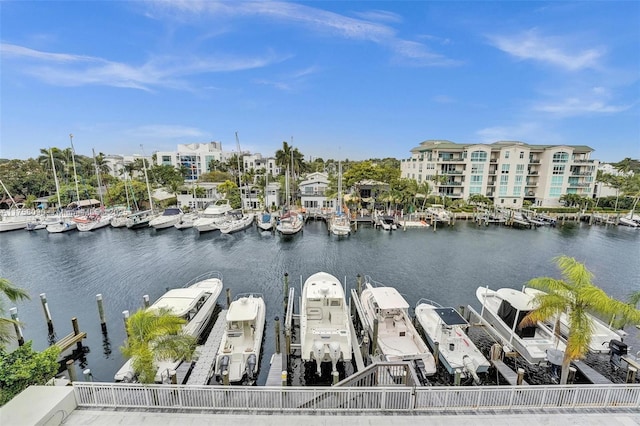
114;271;222;383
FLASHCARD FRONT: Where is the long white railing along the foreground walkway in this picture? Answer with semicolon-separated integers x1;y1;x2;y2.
73;382;640;414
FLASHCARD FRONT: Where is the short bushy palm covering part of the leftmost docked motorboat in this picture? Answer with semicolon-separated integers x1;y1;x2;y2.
120;309;197;383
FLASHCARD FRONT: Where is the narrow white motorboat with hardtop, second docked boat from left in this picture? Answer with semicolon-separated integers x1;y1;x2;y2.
215;293;266;384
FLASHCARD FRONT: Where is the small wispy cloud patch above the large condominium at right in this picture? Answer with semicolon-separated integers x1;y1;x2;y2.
488;29;604;71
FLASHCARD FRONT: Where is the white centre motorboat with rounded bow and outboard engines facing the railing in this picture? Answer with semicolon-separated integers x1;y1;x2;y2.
300;272;352;375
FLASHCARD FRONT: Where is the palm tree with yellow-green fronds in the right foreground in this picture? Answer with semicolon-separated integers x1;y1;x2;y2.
520;256;640;384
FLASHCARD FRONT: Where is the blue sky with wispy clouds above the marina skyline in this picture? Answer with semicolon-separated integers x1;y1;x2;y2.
0;0;640;161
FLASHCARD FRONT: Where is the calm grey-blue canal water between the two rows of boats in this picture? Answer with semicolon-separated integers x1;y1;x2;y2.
0;221;640;384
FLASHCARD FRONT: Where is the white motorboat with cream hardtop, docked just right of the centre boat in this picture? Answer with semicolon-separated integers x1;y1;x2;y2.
360;276;436;376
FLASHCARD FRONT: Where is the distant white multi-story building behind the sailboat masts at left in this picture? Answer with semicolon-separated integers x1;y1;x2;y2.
155;142;225;182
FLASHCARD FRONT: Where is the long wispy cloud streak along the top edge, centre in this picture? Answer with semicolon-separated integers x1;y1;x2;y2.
151;0;458;66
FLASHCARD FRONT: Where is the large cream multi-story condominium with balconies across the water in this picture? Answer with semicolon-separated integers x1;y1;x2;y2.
401;140;598;208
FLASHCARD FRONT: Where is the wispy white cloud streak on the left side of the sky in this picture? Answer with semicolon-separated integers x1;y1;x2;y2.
0;43;284;91
